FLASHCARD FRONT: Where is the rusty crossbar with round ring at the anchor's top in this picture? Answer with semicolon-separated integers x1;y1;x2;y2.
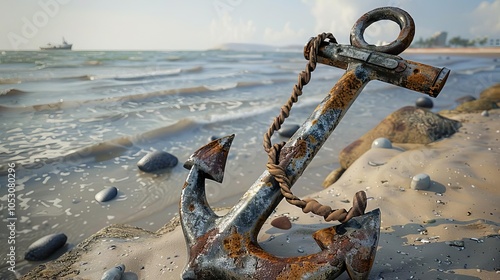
304;7;450;97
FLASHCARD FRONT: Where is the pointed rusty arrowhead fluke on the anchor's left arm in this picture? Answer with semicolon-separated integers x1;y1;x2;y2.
184;134;234;183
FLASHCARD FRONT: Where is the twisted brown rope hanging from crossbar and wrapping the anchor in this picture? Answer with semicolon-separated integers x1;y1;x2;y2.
263;33;366;223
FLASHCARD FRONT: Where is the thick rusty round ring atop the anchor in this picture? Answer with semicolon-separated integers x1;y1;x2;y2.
350;7;415;55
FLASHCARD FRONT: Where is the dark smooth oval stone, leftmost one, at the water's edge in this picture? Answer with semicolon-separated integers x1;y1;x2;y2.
24;233;68;261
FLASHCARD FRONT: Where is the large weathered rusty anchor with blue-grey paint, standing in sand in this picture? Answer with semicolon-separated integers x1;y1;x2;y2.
179;7;449;279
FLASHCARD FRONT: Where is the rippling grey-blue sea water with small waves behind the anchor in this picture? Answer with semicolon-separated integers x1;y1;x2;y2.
0;50;500;279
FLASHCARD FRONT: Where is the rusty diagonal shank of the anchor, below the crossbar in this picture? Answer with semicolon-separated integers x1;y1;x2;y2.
220;64;374;236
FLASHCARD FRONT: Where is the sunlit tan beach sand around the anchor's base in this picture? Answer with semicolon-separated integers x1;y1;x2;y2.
23;105;500;279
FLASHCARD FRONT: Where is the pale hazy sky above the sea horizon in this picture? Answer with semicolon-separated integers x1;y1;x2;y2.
0;0;500;50
